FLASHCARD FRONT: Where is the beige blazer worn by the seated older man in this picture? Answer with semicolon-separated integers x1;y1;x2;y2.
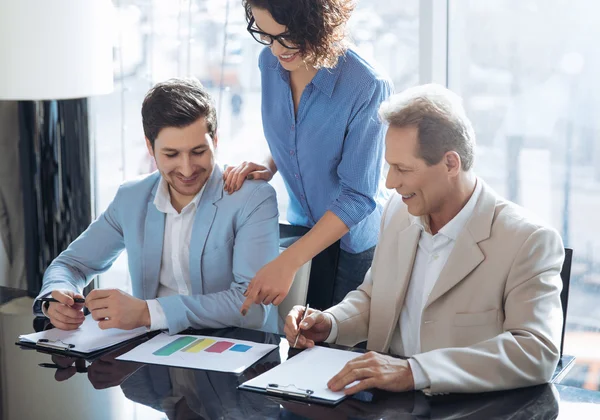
327;180;564;393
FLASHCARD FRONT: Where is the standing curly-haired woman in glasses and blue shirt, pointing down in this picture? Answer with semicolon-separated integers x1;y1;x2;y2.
224;0;392;313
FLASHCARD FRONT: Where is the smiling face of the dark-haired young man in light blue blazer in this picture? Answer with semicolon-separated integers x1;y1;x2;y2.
146;117;217;206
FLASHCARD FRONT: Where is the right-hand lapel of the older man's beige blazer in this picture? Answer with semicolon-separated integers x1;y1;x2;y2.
424;179;496;310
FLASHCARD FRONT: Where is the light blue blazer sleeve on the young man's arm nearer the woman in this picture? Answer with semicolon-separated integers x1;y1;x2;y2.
157;183;279;334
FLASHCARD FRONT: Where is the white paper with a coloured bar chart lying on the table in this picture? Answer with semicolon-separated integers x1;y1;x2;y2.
117;334;277;373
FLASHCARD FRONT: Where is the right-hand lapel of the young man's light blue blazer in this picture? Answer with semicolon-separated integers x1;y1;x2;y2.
190;165;223;295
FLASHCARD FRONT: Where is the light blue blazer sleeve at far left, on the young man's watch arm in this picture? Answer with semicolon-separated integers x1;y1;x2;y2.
38;190;125;308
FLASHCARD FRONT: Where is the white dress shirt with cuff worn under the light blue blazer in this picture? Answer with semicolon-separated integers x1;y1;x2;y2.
147;177;204;331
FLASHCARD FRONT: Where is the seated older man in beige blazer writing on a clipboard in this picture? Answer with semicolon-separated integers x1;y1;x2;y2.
285;85;564;394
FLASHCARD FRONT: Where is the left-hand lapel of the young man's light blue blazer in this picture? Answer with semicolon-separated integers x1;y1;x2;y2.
143;181;165;299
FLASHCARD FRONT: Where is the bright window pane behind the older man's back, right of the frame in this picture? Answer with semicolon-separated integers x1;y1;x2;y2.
448;0;600;389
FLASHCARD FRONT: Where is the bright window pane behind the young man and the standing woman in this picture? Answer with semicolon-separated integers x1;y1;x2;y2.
90;0;419;292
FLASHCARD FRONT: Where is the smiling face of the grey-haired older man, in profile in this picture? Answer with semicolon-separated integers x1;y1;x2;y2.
385;125;455;216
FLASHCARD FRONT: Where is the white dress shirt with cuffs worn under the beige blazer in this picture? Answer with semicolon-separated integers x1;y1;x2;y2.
326;182;482;389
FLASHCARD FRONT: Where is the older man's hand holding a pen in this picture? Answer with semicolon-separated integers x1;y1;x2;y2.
284;305;332;349
